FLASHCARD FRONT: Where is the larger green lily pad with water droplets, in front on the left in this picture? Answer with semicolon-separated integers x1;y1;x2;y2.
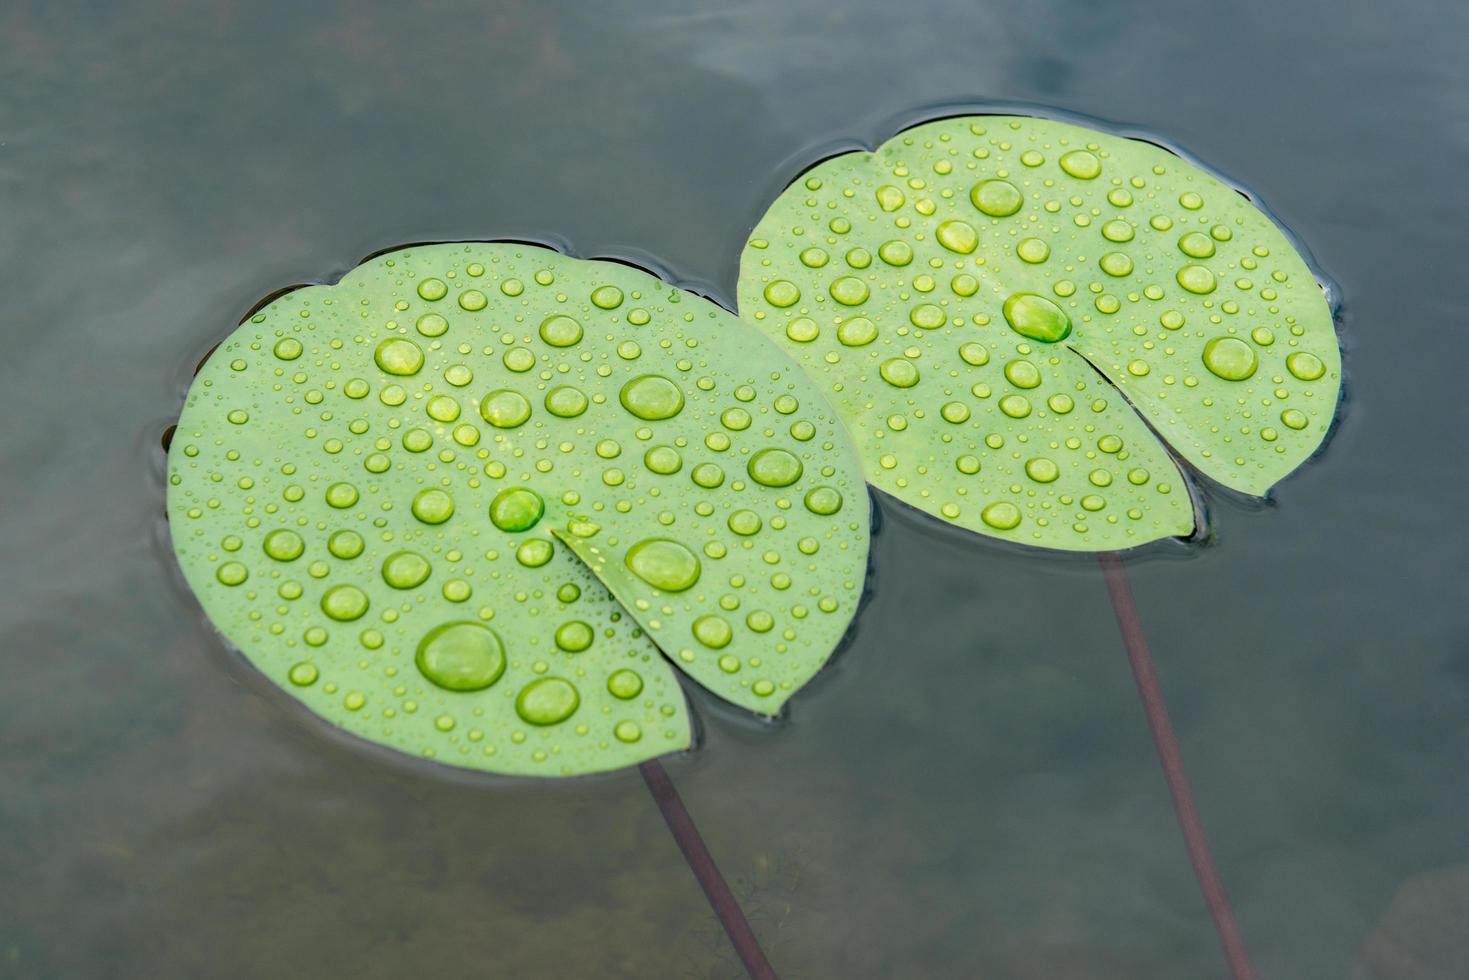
169;244;868;776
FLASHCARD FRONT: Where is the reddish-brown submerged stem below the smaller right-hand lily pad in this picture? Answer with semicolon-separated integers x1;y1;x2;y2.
1097;552;1255;980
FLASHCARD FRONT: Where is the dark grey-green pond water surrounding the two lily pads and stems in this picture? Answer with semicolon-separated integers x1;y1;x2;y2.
0;0;1469;980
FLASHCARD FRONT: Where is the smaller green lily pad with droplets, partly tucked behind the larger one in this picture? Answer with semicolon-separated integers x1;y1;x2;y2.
739;116;1341;551
